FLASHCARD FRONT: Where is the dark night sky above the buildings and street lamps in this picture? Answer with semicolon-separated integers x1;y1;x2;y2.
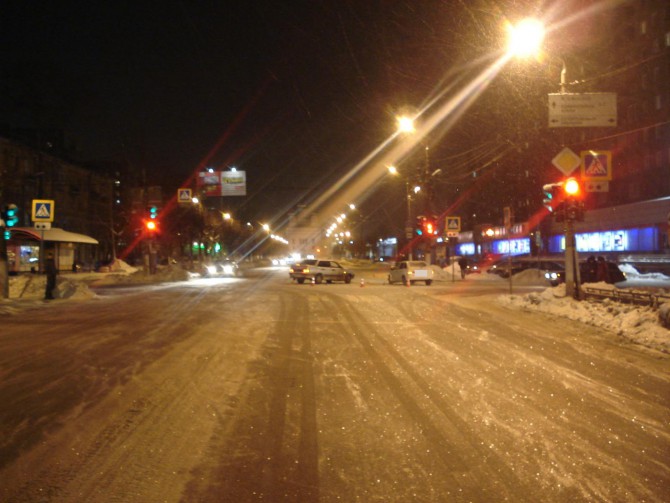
0;0;588;231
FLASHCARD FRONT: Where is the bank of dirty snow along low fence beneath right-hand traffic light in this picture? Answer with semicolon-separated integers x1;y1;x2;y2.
498;284;670;353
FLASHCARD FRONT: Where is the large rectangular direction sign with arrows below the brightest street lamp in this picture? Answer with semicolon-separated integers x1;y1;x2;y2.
549;93;617;127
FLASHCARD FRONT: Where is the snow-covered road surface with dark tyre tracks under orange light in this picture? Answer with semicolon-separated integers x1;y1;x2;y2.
0;268;670;503
